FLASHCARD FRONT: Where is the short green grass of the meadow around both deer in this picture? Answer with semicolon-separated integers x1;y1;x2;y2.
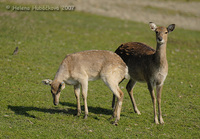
0;3;200;138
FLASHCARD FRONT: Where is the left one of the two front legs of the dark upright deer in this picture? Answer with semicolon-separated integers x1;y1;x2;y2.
148;83;159;124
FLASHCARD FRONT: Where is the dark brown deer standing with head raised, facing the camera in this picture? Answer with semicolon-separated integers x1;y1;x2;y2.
112;22;175;124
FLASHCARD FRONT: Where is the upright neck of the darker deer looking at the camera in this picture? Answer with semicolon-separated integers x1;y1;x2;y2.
155;43;167;67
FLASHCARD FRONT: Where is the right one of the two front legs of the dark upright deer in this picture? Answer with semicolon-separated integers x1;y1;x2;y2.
156;85;164;124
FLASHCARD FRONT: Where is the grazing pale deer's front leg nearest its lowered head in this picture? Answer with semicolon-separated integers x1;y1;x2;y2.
74;84;81;116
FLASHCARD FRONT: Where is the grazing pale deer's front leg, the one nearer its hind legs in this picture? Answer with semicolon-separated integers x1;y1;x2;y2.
81;80;88;119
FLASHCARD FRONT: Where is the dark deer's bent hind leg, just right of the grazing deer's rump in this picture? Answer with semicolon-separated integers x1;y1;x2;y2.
126;79;141;115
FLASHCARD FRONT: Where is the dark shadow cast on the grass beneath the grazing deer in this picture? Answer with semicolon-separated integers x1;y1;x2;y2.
8;102;112;118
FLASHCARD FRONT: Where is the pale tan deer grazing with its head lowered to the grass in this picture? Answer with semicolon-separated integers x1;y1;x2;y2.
43;50;129;125
